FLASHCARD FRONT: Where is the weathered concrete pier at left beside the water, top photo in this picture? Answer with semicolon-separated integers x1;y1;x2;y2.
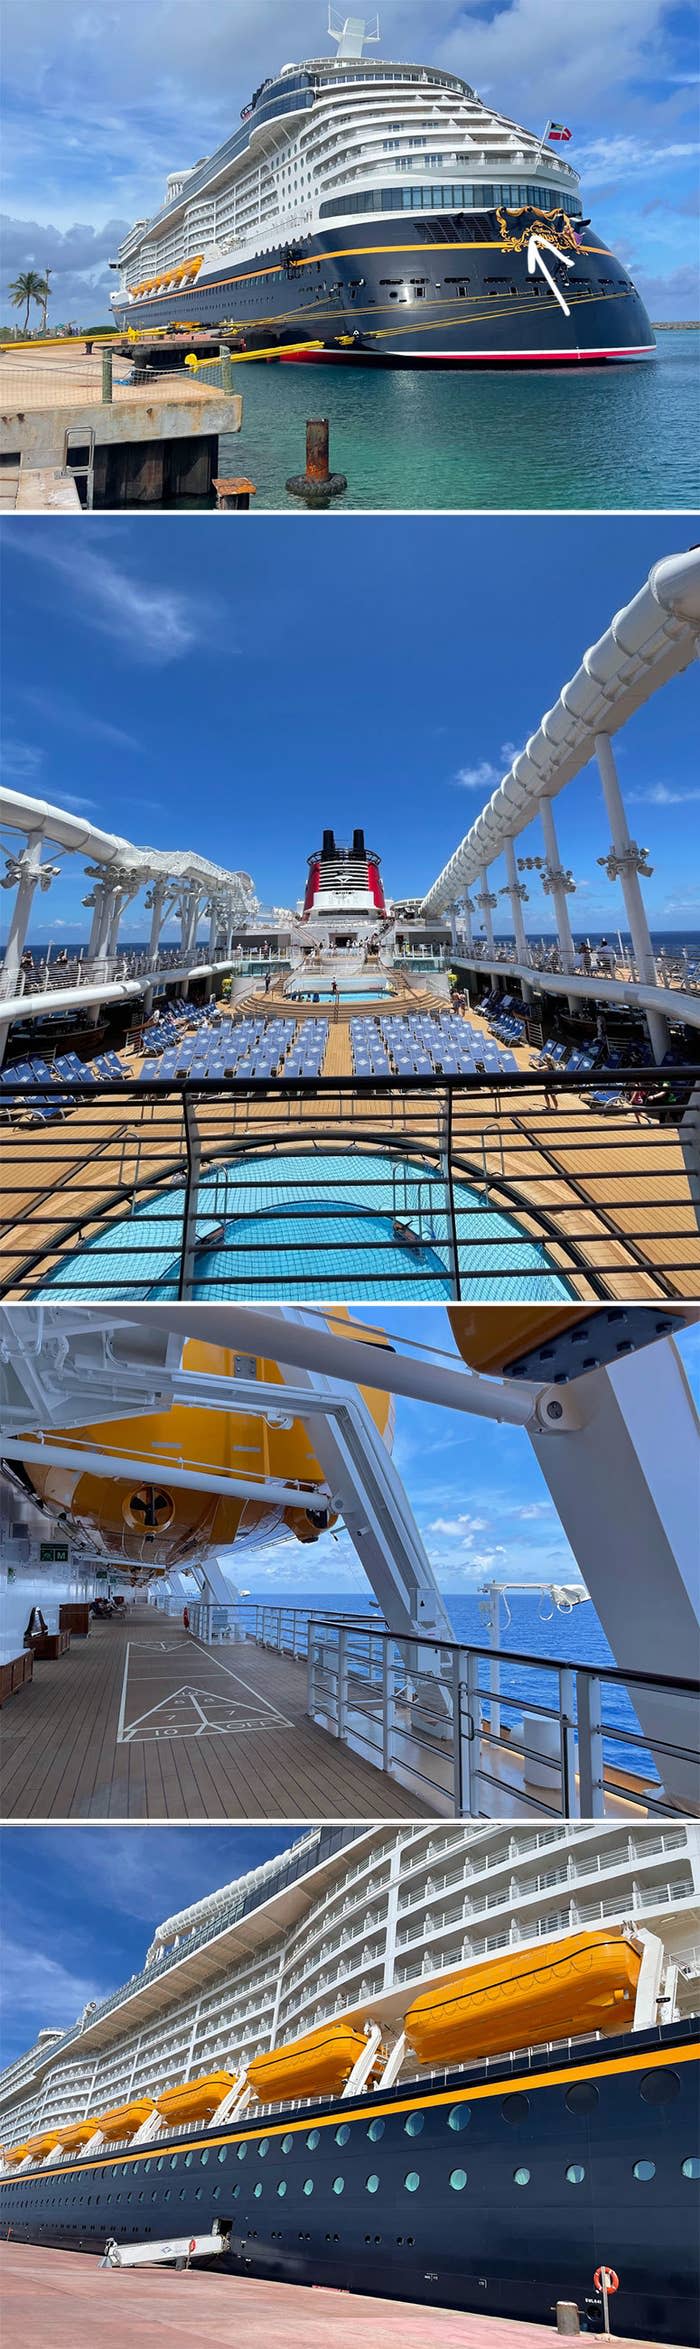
0;348;242;512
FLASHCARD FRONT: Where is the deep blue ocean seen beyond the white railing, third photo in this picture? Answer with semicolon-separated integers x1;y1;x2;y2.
251;1576;658;1778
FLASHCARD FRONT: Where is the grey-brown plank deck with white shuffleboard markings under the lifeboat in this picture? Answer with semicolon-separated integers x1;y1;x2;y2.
0;1604;432;1820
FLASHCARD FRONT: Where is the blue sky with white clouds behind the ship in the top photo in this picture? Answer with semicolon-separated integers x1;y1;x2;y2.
0;0;700;327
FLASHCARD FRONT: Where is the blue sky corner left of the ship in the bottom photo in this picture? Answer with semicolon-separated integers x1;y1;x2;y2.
0;1825;305;2067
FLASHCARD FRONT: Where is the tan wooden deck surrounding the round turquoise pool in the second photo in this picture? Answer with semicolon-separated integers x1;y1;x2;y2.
0;984;700;1299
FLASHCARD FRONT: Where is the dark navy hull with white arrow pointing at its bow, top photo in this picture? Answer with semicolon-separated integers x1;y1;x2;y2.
113;211;655;366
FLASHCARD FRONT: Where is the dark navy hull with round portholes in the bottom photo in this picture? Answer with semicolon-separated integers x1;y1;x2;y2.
2;2025;700;2349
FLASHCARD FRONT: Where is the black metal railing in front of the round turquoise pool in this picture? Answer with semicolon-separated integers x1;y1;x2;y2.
0;1066;700;1301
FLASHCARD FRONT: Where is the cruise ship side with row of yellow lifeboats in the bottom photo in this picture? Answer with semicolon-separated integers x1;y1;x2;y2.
0;1820;700;2344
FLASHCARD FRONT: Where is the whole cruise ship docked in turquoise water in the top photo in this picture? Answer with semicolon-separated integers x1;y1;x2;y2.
110;16;655;366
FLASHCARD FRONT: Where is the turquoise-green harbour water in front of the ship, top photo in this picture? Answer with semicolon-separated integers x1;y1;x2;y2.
218;327;700;514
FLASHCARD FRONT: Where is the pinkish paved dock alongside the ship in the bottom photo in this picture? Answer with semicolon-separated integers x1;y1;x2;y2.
0;2243;676;2349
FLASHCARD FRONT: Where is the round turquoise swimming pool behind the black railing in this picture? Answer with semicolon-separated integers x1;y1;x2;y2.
35;1149;571;1304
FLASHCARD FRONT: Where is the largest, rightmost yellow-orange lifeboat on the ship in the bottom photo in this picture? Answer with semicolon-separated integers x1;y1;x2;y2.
404;1929;641;2065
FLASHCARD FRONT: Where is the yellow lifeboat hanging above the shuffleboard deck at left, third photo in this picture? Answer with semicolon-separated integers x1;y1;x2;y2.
12;1306;392;1574
